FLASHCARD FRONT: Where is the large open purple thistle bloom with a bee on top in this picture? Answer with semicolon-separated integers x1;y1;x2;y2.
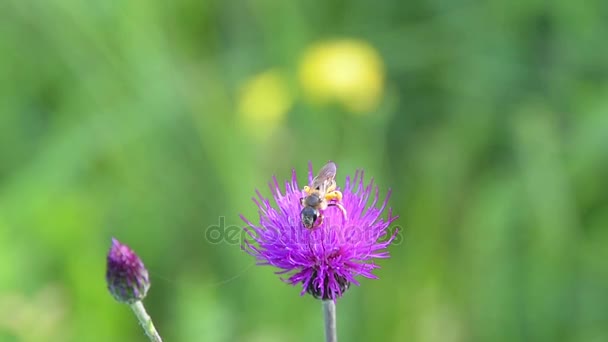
241;164;398;300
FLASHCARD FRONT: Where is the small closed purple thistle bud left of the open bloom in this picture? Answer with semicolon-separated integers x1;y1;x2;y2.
106;238;150;304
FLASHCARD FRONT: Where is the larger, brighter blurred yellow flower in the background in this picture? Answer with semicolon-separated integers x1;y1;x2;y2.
299;39;384;113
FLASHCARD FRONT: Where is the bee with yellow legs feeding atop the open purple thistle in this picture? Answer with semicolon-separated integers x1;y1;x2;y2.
300;161;346;229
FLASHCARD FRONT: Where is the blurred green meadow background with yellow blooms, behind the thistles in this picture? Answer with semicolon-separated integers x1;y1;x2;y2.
0;0;608;342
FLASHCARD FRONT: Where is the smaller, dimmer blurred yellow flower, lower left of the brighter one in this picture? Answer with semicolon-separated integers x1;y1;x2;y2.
238;69;293;138
